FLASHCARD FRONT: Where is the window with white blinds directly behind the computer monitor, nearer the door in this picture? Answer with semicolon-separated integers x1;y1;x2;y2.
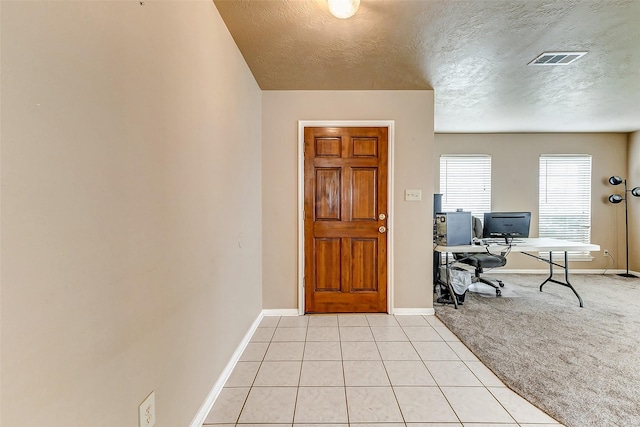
440;154;491;220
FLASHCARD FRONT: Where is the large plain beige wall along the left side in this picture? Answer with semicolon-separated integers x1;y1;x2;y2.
0;0;262;427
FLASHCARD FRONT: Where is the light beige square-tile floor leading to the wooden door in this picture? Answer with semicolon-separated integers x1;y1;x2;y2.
205;314;560;427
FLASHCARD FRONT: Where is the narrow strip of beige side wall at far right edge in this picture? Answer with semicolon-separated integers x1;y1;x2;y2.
627;132;640;273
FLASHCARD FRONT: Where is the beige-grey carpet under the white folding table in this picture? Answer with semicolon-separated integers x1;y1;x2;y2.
434;274;640;427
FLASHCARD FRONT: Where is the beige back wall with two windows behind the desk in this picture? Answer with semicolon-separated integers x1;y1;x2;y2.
433;133;627;269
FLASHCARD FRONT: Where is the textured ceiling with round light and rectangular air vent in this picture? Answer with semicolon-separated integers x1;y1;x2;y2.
214;0;640;132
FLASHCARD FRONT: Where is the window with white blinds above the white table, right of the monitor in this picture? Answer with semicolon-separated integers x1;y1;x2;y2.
539;154;591;259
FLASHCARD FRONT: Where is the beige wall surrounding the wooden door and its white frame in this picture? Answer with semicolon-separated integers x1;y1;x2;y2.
262;91;434;309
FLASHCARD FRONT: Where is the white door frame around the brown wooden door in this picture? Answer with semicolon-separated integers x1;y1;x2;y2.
298;120;395;316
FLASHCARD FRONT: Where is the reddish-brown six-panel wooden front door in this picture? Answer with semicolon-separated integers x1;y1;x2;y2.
304;127;388;313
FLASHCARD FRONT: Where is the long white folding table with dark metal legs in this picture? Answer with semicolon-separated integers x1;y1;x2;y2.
434;237;600;308
